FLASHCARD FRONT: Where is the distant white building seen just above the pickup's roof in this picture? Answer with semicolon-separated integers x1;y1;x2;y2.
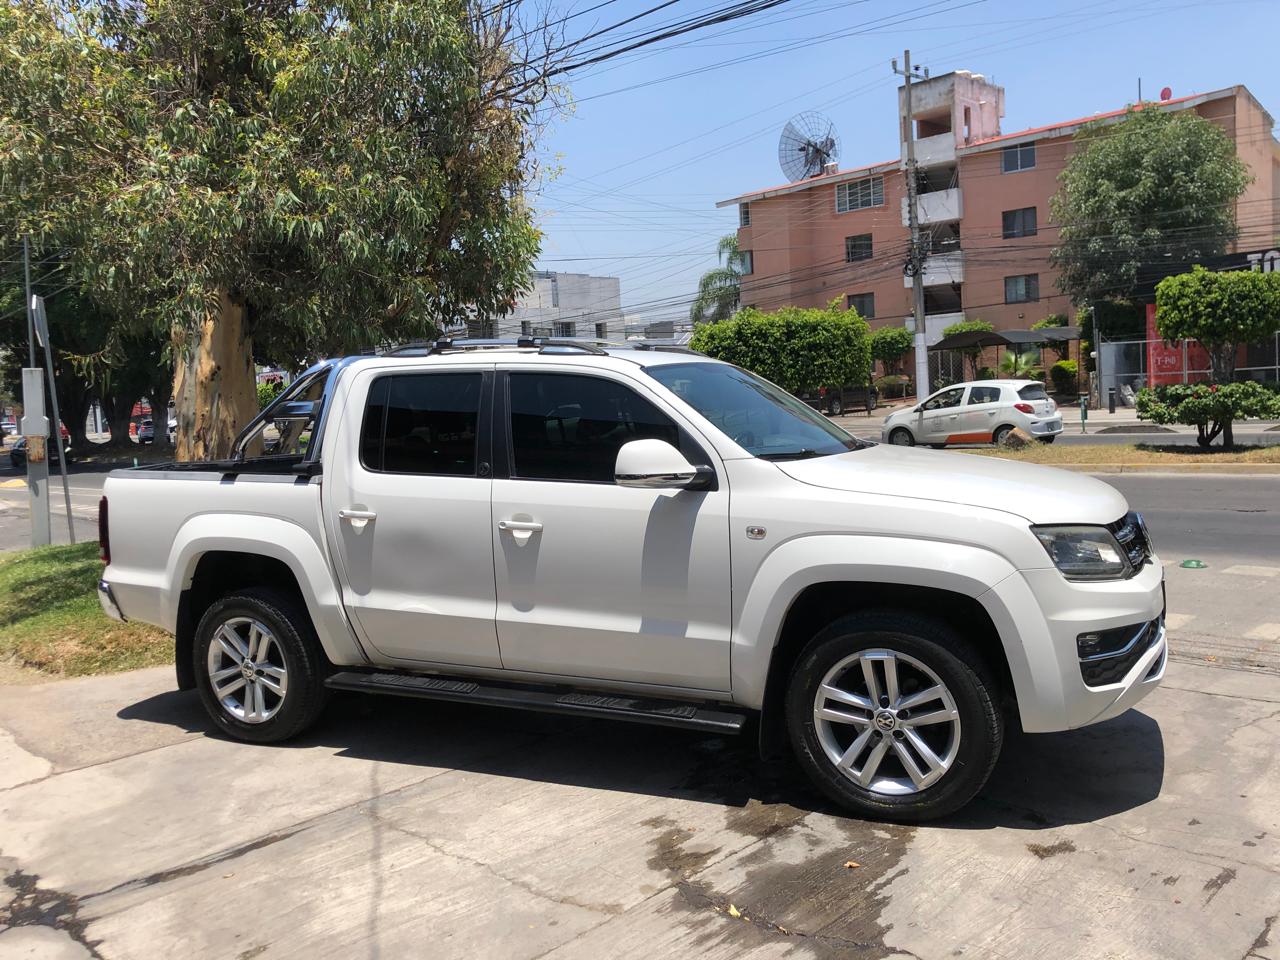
467;270;622;340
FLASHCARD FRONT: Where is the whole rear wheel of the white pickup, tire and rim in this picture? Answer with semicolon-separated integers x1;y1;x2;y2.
193;589;326;744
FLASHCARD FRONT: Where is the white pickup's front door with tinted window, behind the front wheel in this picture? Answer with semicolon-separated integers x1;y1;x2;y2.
492;362;732;690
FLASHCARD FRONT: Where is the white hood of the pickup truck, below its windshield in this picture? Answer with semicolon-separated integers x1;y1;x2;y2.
776;444;1129;524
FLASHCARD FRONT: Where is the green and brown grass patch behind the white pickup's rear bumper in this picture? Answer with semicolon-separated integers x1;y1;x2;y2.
0;543;173;677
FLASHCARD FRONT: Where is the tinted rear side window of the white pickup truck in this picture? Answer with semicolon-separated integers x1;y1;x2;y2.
360;374;481;476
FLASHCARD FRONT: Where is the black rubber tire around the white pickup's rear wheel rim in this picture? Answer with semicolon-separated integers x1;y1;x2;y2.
192;589;329;744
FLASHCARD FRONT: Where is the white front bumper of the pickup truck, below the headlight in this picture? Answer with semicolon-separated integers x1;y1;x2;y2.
982;558;1169;733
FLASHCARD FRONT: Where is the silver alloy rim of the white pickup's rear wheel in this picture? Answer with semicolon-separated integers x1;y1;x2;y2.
207;617;289;723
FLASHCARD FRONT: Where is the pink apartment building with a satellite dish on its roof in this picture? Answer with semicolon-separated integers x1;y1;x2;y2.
717;70;1280;371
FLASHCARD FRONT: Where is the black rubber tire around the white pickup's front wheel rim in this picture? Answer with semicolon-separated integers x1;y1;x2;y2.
786;609;1004;822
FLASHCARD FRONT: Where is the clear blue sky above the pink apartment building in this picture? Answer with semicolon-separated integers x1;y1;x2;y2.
532;0;1280;330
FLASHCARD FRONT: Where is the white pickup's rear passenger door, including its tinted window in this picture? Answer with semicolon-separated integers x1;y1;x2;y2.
324;361;502;667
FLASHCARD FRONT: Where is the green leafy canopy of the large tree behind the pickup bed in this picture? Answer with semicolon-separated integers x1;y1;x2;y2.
0;0;549;364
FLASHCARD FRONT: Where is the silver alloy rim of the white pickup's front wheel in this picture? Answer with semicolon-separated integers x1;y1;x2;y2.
813;649;961;796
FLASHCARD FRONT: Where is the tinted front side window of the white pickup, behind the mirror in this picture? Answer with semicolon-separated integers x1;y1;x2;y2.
509;374;680;484
